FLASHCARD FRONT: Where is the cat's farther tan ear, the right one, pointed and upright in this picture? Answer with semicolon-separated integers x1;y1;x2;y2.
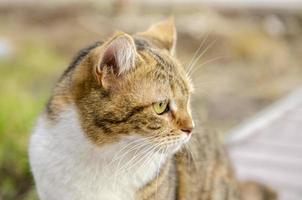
138;17;177;55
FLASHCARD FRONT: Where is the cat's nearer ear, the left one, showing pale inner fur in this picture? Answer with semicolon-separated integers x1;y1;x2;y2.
95;33;137;86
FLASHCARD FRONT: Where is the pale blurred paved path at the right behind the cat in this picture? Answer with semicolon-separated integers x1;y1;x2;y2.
228;88;302;200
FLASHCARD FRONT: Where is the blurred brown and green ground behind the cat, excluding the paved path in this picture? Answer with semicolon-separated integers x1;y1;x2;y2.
0;0;302;200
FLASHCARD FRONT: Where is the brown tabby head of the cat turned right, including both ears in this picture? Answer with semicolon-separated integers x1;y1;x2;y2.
53;19;194;154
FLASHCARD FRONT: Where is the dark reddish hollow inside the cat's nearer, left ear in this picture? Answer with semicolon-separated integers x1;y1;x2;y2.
100;46;119;74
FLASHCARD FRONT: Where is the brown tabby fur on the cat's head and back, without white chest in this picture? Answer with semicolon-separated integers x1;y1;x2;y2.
47;19;276;200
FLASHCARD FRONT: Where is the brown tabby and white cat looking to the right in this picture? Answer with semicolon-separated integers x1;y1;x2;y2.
29;19;249;200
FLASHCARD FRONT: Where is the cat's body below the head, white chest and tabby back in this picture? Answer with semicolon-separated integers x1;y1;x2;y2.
31;106;239;200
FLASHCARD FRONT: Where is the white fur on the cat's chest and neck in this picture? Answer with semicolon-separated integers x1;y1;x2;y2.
29;108;165;200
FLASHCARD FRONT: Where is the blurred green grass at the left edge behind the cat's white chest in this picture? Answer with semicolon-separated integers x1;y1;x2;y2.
0;40;65;199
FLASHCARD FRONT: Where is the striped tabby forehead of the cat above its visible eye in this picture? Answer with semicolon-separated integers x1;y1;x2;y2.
130;44;191;102
